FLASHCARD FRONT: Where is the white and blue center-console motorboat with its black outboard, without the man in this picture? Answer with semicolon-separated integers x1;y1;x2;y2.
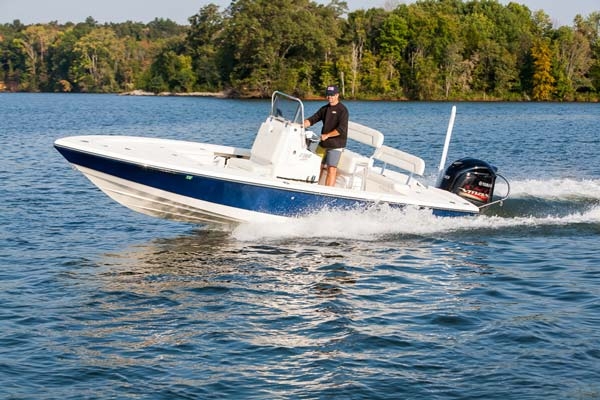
54;91;508;224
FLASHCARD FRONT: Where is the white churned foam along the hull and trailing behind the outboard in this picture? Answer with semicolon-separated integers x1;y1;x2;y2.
232;179;600;241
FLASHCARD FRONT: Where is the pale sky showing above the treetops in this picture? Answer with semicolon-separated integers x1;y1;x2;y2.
0;0;600;25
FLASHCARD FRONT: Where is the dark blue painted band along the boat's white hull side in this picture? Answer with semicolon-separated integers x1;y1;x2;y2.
55;146;469;217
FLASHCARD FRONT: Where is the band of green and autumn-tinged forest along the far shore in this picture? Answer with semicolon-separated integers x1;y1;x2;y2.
0;0;600;101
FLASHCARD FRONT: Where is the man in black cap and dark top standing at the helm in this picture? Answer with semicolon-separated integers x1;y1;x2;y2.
304;86;349;186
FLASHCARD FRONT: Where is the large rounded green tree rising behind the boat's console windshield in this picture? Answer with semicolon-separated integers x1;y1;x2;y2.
221;0;340;97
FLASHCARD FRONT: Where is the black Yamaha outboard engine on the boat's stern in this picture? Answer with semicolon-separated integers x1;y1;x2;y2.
438;158;499;207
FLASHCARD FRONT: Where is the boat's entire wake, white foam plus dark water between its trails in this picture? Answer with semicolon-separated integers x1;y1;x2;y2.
232;179;600;241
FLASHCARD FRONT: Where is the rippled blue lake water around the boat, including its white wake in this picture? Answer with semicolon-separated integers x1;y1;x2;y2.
0;94;600;400
